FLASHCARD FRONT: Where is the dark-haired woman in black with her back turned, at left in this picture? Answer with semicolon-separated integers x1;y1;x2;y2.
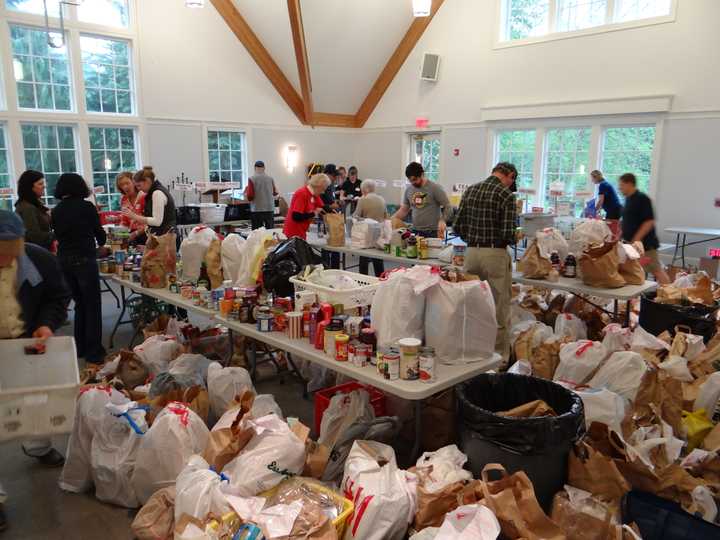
52;173;107;364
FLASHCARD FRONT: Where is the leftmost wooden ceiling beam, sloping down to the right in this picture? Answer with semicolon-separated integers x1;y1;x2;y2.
210;0;307;124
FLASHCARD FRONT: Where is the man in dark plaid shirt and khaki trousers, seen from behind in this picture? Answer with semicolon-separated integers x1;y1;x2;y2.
453;162;517;363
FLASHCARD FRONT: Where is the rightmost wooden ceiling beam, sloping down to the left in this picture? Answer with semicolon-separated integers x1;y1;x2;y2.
355;0;443;127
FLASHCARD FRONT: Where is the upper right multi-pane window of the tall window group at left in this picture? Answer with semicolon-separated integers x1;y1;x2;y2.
80;36;133;114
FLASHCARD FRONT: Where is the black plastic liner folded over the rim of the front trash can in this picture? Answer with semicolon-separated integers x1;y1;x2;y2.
455;373;585;455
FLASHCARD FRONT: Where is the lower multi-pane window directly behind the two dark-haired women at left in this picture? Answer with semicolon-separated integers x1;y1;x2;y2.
21;124;78;203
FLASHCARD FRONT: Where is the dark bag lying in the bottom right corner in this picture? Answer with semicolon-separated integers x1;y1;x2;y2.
622;490;720;540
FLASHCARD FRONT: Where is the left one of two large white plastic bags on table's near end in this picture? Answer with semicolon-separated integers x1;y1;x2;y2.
370;265;440;347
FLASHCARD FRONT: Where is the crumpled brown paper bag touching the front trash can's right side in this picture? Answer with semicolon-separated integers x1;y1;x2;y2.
568;443;630;503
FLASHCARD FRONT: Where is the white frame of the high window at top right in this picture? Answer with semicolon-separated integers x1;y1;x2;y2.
493;0;678;49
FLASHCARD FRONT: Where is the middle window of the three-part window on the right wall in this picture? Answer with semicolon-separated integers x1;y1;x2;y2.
545;128;590;214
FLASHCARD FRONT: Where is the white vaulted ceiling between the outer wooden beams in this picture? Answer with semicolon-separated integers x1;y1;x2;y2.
233;0;420;114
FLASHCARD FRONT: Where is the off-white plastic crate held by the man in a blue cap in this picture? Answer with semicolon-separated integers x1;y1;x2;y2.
0;337;80;441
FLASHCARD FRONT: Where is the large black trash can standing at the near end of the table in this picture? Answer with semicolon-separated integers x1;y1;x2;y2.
456;373;585;512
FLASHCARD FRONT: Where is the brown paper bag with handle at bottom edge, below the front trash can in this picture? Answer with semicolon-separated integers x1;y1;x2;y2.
481;463;566;540
